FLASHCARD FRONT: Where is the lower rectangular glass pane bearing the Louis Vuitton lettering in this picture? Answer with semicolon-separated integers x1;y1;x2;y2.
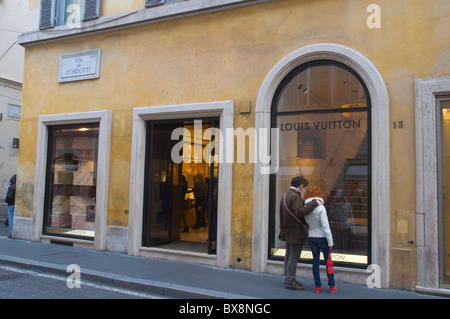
271;112;370;265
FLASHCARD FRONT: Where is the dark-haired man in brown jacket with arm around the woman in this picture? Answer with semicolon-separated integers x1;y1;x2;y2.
280;176;322;290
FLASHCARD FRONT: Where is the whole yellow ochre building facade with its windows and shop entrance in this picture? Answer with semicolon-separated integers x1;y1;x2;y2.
13;0;450;294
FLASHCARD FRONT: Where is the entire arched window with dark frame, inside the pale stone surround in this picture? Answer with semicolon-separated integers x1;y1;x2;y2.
269;60;371;268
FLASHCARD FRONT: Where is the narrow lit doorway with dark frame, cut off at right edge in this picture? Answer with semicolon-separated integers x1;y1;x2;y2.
438;98;450;287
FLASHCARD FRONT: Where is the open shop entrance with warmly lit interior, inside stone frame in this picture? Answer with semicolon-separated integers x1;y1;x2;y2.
142;118;220;254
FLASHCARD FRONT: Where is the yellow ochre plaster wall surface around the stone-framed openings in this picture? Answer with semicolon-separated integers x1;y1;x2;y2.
17;0;450;287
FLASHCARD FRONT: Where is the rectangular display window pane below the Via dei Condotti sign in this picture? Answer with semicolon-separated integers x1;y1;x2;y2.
44;124;99;239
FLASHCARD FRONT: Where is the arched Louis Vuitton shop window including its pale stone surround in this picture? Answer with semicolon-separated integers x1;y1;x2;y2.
253;44;389;288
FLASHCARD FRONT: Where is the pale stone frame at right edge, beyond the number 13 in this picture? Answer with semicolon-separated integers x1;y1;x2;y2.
415;76;450;294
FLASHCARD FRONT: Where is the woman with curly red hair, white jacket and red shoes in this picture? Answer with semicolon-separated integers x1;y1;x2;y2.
304;186;337;293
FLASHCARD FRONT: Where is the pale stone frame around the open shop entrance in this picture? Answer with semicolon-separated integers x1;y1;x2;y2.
128;101;234;268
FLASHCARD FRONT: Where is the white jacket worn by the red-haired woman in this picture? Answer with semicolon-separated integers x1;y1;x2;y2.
305;197;333;246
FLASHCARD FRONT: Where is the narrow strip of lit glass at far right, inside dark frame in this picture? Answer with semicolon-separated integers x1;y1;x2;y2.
441;106;450;285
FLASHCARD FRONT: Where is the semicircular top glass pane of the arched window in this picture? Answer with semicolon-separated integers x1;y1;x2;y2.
276;63;367;112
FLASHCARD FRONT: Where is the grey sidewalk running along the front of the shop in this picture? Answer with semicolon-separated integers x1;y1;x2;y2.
0;237;448;299
